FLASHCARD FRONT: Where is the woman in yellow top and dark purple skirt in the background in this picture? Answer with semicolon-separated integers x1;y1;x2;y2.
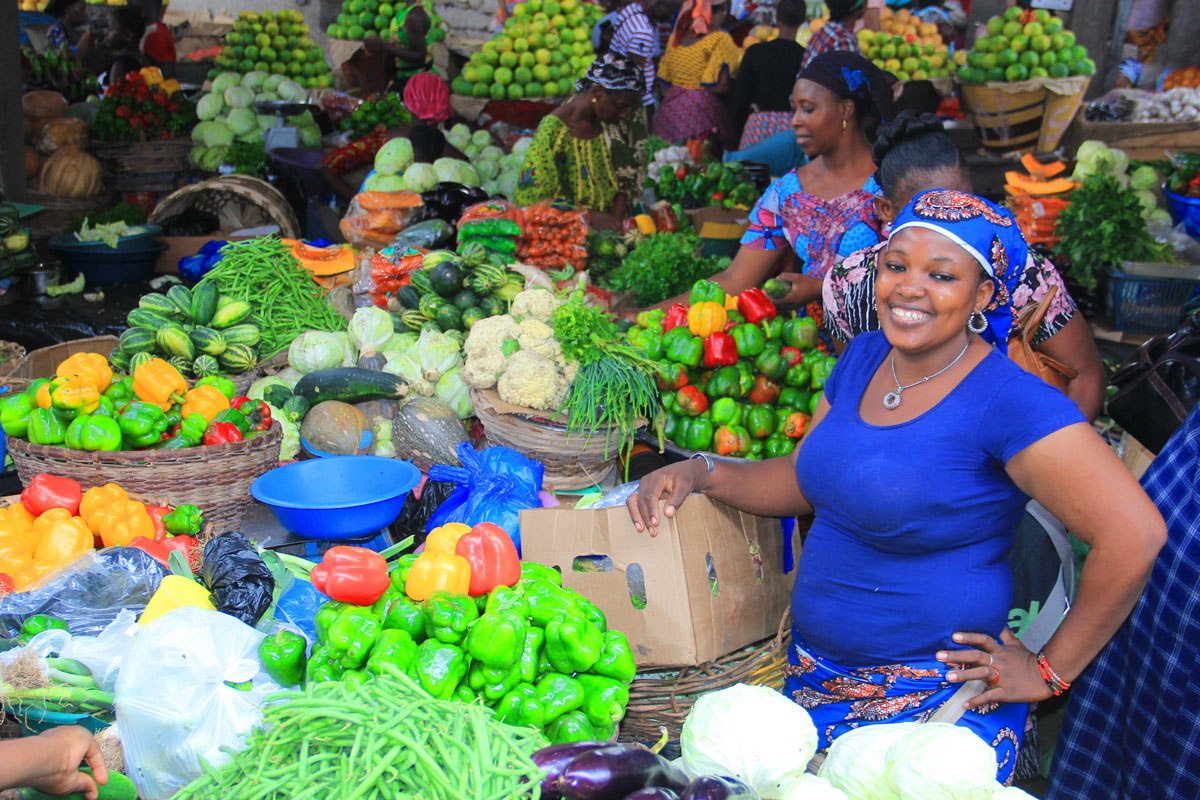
654;0;738;146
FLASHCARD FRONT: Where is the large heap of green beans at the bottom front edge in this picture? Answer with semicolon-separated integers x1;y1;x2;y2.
173;666;546;800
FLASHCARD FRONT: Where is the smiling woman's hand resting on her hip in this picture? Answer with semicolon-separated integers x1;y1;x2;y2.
937;627;1051;709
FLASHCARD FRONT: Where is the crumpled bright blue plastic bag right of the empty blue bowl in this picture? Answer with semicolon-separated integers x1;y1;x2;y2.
425;441;545;553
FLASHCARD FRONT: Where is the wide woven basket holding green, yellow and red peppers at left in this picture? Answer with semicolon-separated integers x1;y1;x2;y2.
8;423;283;534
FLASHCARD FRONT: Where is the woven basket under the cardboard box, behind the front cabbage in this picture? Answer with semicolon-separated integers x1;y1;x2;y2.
620;610;792;758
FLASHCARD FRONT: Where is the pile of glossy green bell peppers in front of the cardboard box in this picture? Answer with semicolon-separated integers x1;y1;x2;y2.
302;557;636;742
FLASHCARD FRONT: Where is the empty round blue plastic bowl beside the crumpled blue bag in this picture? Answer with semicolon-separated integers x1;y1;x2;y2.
250;456;421;541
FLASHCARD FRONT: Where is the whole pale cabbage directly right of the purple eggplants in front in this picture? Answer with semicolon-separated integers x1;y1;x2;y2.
679;684;820;798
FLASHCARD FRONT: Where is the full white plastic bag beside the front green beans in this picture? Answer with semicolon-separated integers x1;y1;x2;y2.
115;608;281;800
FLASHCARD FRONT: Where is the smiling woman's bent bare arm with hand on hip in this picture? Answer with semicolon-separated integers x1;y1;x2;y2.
938;422;1166;708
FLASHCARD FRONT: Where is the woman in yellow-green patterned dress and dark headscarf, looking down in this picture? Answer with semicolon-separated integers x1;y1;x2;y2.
512;53;643;228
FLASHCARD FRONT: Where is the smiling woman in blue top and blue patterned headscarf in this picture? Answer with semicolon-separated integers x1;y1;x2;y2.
629;190;1165;781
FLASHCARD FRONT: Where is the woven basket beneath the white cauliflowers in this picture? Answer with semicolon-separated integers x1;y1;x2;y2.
470;389;620;489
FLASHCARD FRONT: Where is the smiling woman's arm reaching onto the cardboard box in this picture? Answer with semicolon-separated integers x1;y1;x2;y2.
625;396;829;536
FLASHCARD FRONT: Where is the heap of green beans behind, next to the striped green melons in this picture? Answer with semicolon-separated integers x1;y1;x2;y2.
202;236;347;359
